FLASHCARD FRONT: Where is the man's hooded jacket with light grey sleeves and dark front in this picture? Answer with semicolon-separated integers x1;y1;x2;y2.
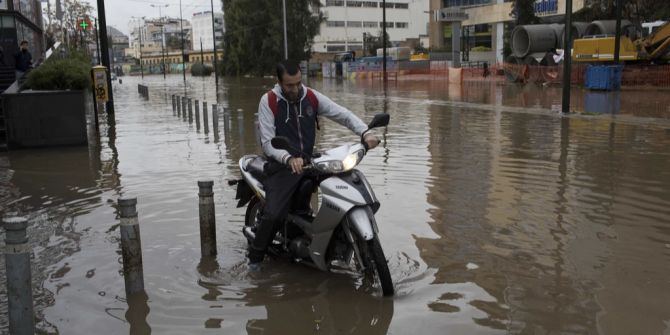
258;84;368;164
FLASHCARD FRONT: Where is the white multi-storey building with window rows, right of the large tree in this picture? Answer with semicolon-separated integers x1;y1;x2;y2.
312;0;429;53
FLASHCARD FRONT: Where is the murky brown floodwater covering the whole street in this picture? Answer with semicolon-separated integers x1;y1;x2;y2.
0;76;670;334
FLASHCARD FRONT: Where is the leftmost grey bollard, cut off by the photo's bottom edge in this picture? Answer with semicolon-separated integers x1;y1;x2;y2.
2;217;35;335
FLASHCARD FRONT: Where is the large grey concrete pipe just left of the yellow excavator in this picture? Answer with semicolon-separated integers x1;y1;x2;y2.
512;24;557;58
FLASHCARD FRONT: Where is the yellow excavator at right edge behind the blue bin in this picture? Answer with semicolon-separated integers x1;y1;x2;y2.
572;22;670;64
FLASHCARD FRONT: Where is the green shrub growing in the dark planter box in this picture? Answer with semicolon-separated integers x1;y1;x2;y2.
25;53;91;90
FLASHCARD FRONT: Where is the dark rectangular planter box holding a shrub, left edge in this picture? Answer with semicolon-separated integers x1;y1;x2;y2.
2;87;93;148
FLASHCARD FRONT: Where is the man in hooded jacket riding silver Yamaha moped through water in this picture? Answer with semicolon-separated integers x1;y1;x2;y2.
233;61;393;295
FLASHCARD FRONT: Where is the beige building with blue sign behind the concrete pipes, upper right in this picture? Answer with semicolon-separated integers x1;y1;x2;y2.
429;0;587;63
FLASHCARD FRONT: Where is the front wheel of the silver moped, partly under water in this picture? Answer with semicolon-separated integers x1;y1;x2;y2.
357;235;394;297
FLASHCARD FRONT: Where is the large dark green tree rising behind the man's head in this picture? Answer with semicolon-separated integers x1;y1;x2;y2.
223;0;324;75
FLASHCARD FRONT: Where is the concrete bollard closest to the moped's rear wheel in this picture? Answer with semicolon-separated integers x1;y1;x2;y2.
198;180;216;257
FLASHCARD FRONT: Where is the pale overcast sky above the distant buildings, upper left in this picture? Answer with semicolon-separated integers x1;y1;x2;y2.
59;0;221;35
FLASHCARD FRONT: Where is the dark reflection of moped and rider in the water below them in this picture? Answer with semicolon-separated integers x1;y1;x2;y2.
244;275;394;335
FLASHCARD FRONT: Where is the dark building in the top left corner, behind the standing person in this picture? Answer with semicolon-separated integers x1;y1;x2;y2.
0;0;45;66
